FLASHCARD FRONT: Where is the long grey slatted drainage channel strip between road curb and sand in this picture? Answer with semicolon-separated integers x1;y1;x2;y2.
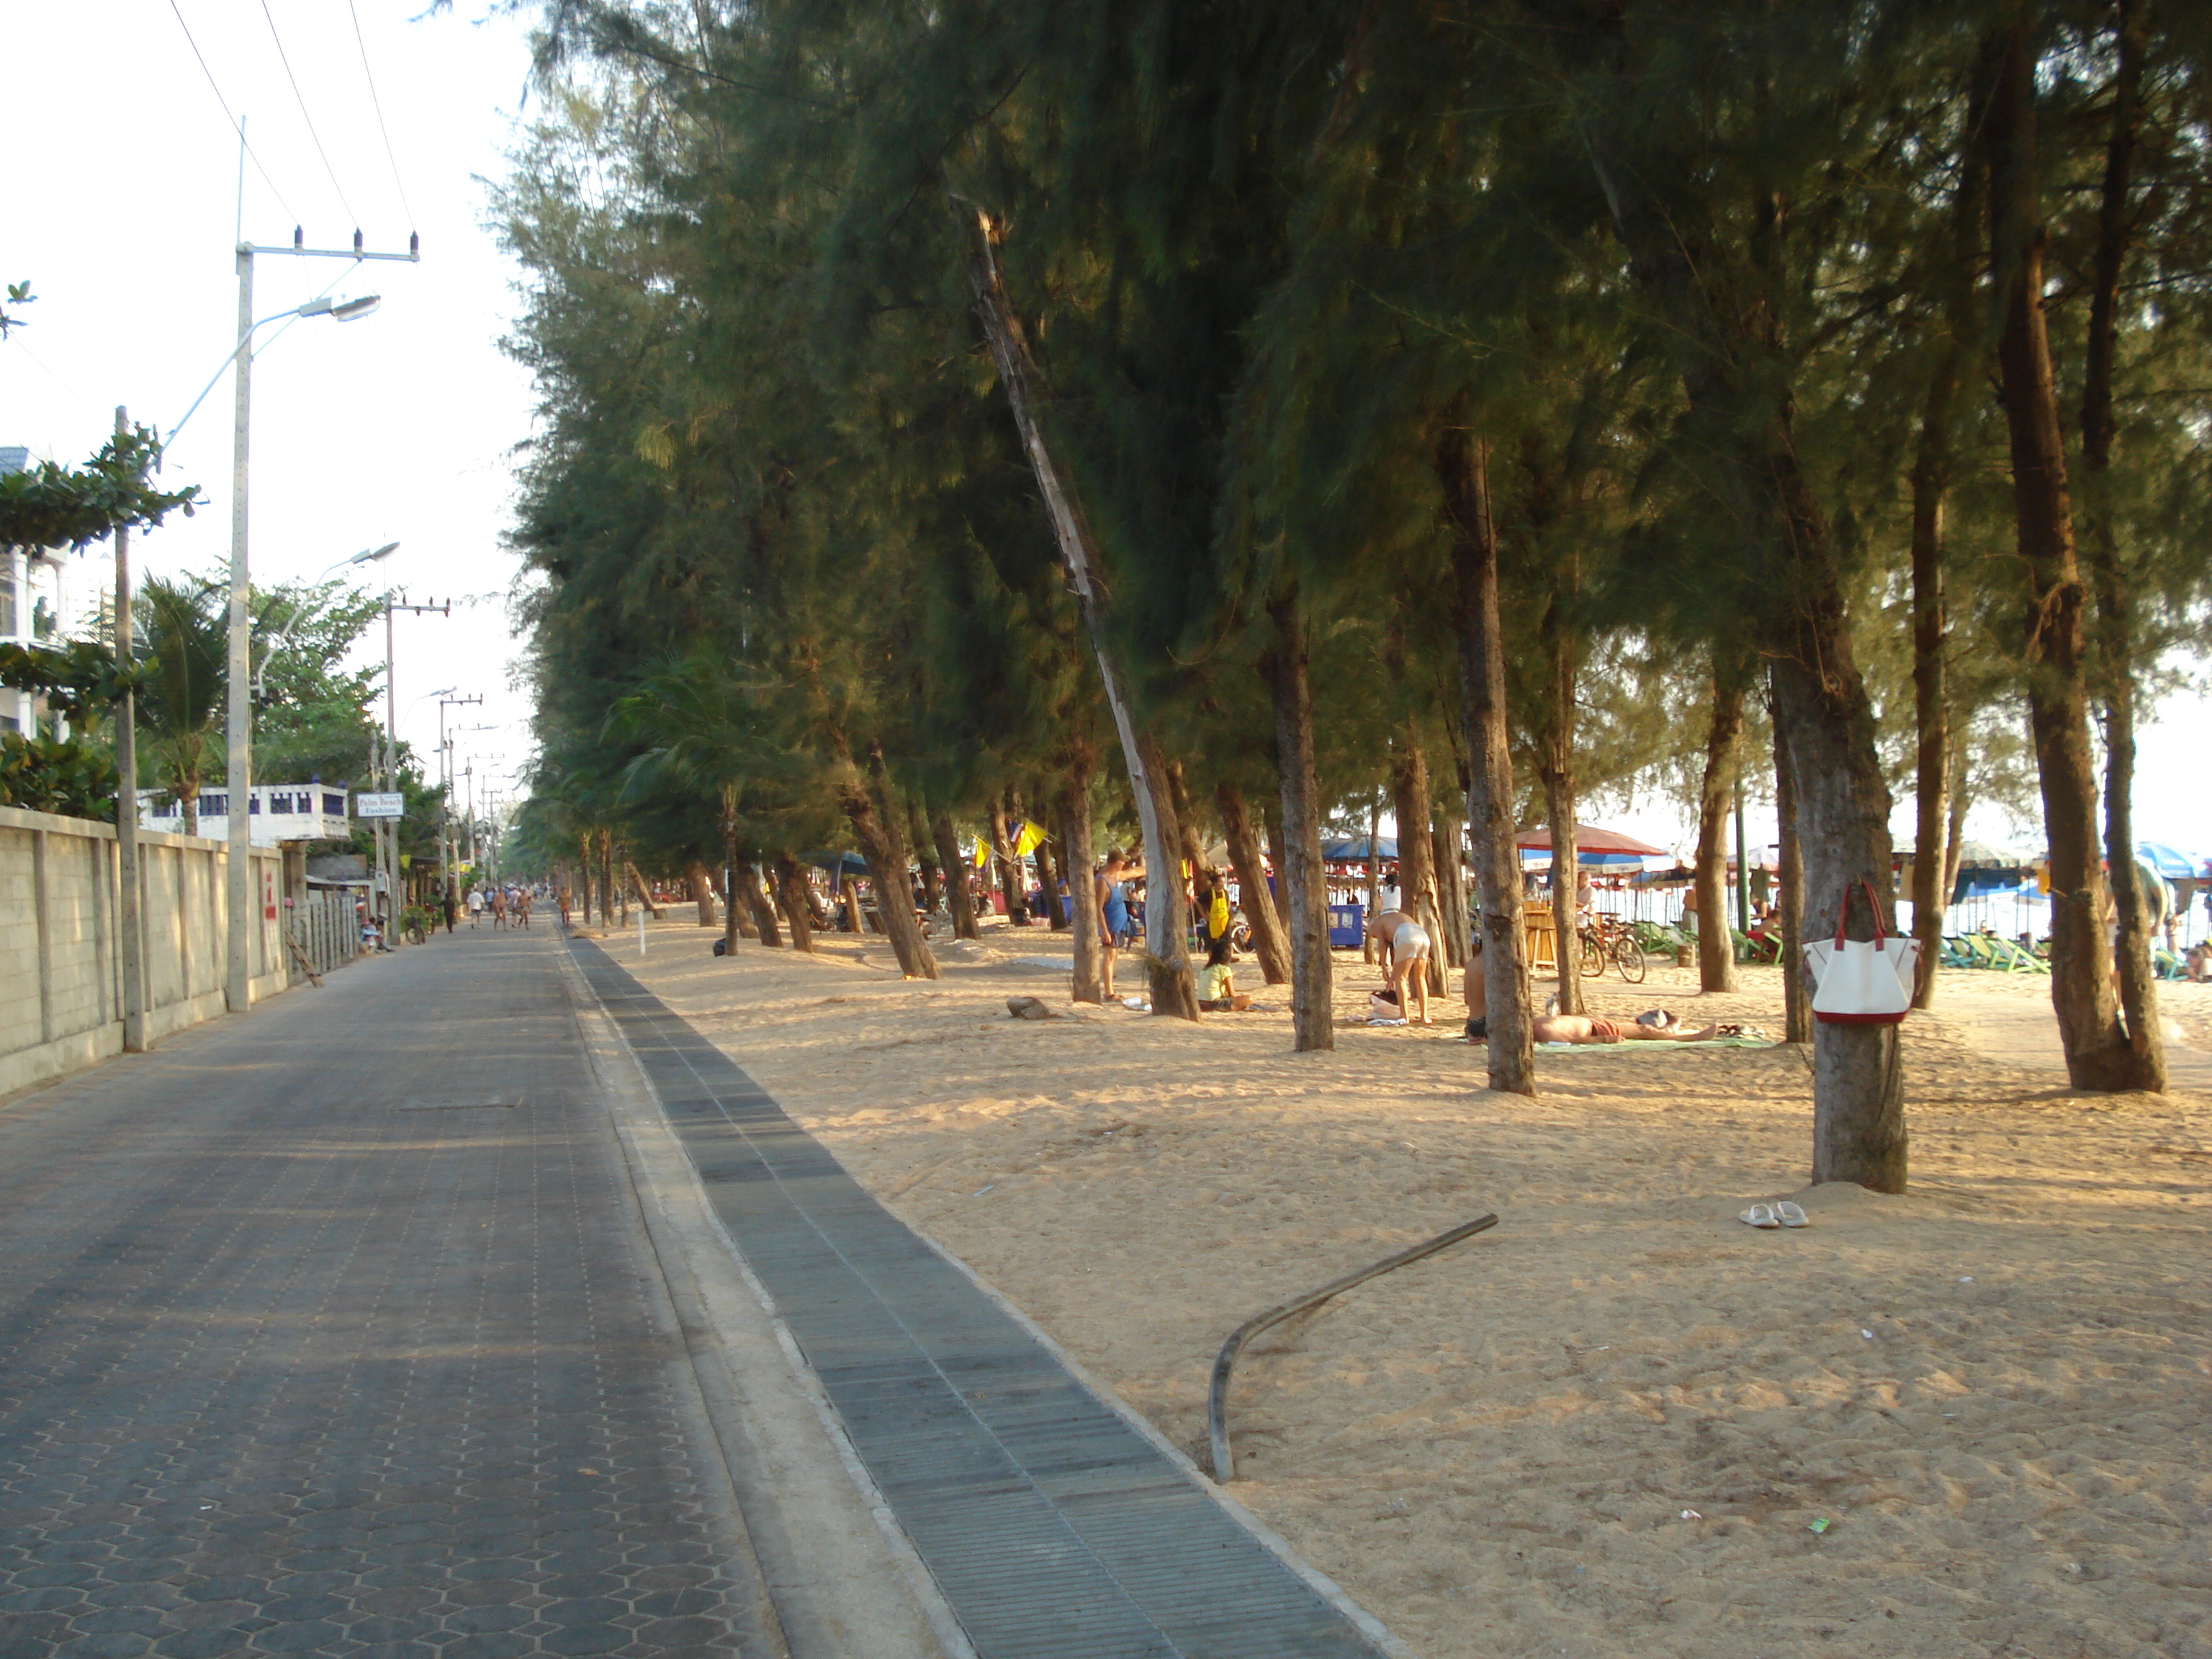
573;940;1398;1659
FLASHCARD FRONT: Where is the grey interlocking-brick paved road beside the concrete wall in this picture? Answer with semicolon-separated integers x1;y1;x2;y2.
0;929;781;1659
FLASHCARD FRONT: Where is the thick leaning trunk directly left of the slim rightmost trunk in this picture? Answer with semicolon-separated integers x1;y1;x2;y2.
1984;20;2150;1090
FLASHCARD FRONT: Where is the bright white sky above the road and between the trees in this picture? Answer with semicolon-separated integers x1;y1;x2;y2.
0;0;2212;871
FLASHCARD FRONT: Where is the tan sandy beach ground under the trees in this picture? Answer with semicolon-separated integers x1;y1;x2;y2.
588;912;2212;1659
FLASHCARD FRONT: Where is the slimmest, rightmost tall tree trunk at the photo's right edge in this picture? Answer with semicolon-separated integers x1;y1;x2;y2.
2082;0;2165;1093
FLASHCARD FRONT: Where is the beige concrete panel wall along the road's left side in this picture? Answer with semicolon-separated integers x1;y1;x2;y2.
0;807;292;1093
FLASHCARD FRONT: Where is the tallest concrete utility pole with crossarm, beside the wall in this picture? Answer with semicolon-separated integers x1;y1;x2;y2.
224;231;423;1013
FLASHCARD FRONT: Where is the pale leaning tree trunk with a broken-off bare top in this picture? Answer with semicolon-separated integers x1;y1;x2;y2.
962;208;1199;1020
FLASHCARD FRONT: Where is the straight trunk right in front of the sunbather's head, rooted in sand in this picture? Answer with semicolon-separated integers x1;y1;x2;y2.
1436;428;1535;1095
